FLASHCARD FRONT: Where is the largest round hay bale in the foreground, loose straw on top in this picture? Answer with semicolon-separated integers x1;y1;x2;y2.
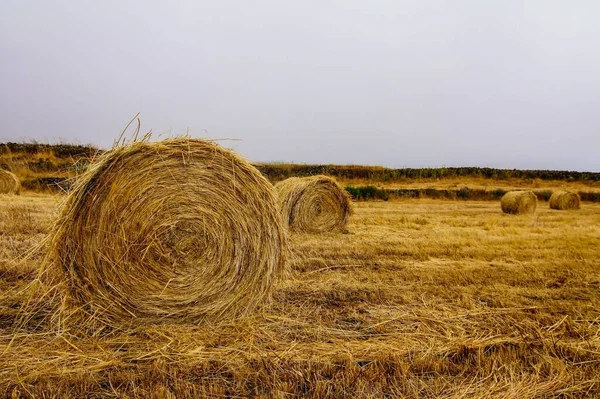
45;139;287;324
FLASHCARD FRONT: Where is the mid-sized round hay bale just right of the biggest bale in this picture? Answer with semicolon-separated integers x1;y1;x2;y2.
275;176;352;233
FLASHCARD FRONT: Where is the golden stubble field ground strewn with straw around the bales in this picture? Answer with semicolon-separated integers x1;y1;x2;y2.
0;193;600;398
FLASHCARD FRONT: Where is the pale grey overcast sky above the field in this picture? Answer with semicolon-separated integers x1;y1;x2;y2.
0;0;600;172
